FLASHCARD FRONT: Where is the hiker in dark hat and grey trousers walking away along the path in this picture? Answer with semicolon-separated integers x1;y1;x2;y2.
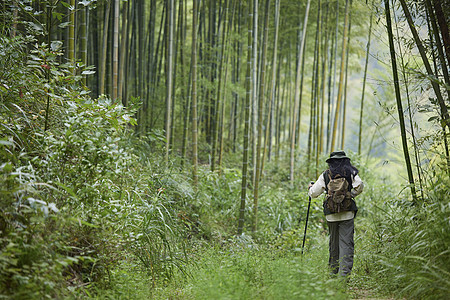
308;151;364;277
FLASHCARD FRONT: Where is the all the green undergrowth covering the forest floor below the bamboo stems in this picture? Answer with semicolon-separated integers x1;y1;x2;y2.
0;11;450;299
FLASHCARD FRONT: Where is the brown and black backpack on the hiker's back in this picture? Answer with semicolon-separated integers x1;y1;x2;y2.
324;170;352;213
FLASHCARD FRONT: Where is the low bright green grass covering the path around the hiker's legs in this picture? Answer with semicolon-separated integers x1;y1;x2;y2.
86;219;408;299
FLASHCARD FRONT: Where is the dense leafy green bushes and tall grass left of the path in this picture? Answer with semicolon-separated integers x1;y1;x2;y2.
0;75;190;299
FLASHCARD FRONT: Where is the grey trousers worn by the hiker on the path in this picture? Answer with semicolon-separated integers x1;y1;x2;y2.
328;219;355;276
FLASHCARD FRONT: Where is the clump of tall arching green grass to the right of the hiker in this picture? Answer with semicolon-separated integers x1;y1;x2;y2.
362;173;450;299
